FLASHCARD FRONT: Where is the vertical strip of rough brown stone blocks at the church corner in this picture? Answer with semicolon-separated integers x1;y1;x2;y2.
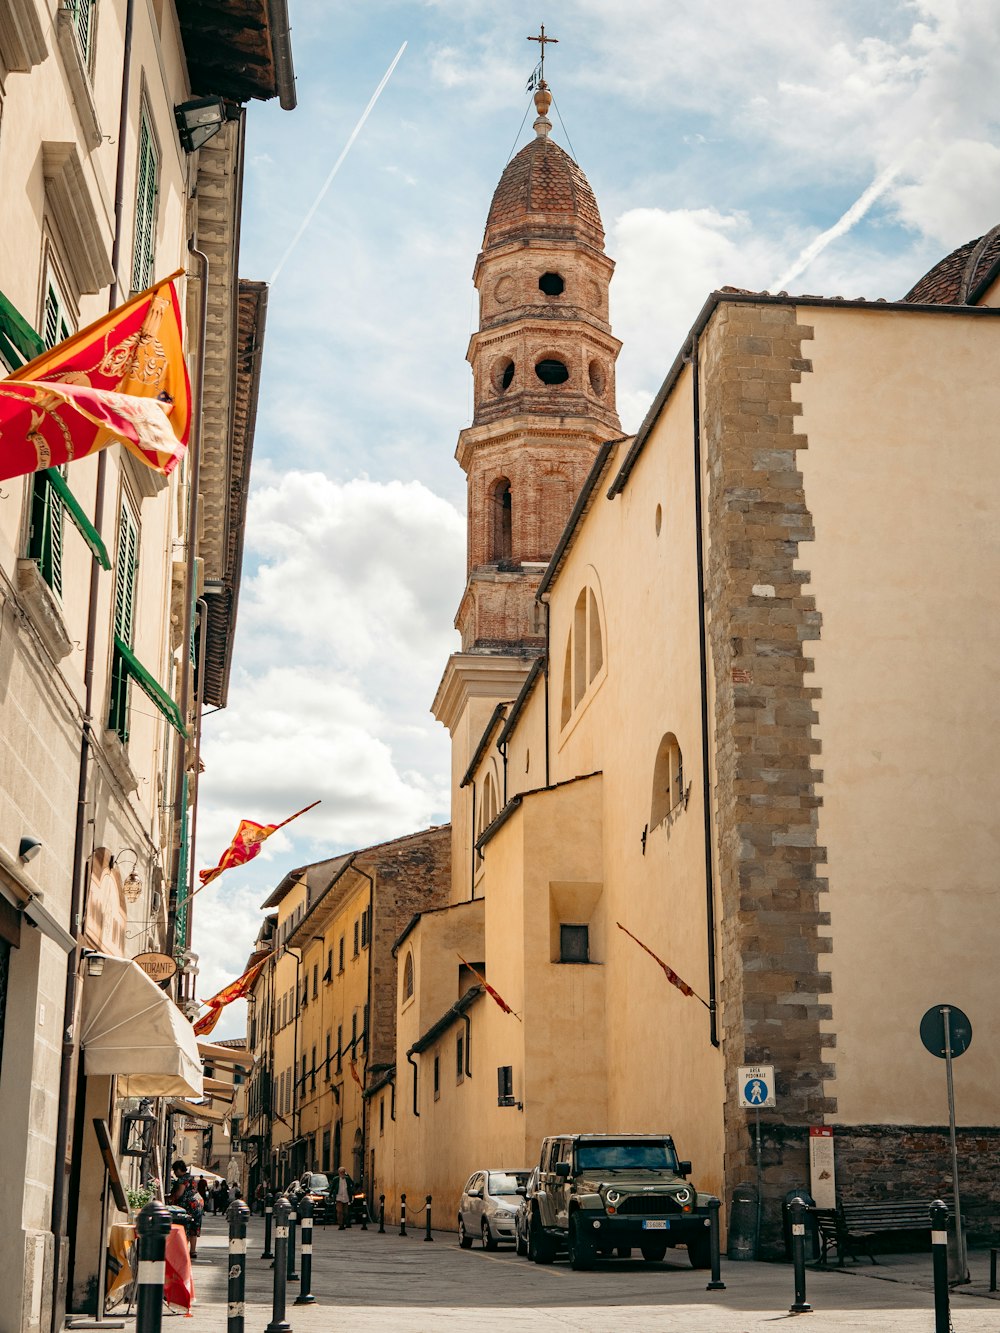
699;303;836;1253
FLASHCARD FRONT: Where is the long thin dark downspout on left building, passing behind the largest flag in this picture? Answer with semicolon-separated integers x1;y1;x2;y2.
51;0;135;1311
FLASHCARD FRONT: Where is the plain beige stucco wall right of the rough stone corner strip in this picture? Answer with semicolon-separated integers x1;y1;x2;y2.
800;309;1000;1125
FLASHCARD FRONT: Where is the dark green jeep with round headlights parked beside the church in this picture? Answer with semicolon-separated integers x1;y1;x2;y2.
528;1134;712;1269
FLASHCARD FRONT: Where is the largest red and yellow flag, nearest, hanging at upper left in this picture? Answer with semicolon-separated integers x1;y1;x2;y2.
0;269;191;481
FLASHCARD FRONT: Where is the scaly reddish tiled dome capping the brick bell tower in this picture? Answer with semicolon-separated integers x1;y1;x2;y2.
483;133;604;249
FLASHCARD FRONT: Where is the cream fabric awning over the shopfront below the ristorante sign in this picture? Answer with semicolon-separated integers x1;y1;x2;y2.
80;954;204;1097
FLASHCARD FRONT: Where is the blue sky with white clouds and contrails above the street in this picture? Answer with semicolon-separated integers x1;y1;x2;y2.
193;0;1000;1037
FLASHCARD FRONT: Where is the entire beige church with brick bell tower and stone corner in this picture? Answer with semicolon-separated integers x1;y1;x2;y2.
367;88;1000;1253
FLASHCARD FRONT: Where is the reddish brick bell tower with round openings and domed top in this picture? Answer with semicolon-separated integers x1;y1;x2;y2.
455;79;621;655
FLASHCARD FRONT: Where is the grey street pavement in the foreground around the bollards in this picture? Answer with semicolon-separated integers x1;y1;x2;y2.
139;1217;1000;1333
